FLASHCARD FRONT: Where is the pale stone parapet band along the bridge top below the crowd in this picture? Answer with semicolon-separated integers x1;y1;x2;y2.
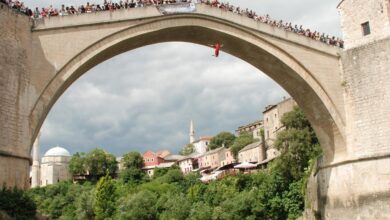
32;4;342;57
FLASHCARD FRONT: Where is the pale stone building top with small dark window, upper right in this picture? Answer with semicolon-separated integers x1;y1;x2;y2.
338;0;390;49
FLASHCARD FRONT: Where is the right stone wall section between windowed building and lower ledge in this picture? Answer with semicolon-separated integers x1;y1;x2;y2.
342;36;390;158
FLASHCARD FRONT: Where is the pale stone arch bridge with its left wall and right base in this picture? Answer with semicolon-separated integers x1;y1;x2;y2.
0;2;390;219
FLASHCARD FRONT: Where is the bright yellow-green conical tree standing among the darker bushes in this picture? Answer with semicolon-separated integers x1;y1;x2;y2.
94;175;117;220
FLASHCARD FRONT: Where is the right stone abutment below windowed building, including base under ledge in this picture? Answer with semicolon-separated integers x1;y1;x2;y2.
304;33;390;220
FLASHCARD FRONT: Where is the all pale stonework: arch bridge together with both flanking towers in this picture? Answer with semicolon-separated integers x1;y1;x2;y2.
0;0;390;219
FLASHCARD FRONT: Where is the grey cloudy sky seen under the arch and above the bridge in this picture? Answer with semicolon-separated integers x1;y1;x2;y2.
25;0;341;156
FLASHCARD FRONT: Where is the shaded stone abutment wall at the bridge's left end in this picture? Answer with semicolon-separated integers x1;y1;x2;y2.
0;3;32;188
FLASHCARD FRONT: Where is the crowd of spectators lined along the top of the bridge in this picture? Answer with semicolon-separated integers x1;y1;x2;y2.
0;0;344;48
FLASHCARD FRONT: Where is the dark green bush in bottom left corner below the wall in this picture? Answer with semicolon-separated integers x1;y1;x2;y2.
0;187;36;220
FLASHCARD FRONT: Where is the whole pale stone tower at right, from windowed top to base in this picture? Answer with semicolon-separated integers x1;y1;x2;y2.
312;0;390;219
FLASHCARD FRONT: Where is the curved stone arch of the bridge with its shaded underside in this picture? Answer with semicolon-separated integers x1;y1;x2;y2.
29;14;345;162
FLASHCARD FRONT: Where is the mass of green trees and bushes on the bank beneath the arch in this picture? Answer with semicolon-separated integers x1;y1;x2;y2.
25;108;321;220
